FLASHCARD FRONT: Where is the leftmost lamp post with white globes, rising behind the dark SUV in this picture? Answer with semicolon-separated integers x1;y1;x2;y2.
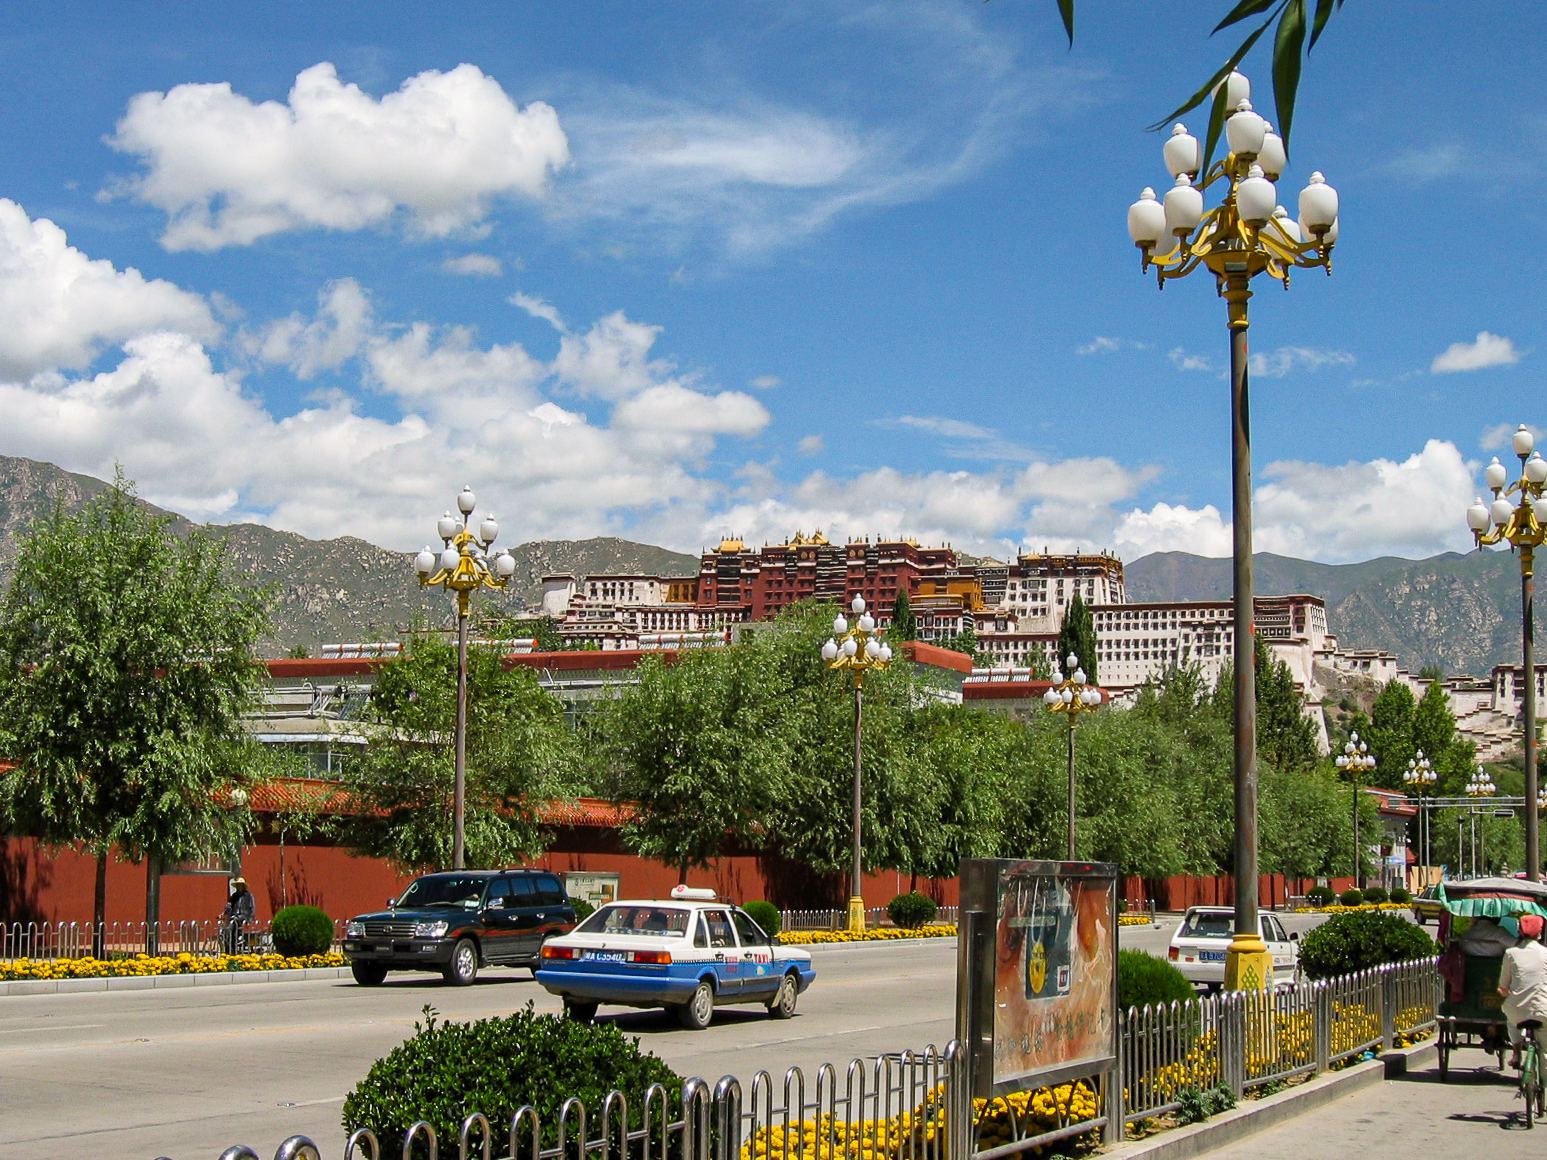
413;487;515;869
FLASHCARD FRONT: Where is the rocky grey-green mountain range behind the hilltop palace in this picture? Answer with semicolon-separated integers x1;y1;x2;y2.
0;456;1521;676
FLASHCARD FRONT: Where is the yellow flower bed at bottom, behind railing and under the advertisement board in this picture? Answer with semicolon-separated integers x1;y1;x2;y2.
741;1083;1100;1160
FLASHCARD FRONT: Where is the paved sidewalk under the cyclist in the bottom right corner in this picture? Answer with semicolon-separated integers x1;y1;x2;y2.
1205;1050;1547;1160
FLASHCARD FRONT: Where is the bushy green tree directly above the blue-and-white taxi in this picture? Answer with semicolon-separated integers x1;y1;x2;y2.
606;645;791;882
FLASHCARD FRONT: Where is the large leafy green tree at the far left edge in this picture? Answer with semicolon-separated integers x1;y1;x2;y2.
0;473;268;946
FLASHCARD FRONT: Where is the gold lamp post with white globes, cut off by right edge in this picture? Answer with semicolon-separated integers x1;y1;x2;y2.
1467;424;1547;882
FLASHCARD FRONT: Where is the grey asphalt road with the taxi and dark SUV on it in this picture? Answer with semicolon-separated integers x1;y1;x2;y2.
0;916;1417;1160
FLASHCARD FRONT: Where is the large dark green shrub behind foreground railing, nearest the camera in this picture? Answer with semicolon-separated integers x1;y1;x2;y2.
343;1002;682;1155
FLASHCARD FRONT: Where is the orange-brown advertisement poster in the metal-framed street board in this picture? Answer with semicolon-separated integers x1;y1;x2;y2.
993;861;1117;1084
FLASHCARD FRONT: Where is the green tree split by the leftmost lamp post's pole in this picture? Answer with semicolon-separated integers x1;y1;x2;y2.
345;633;579;871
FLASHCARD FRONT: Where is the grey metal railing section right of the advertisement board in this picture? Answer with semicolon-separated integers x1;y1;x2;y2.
1118;959;1440;1121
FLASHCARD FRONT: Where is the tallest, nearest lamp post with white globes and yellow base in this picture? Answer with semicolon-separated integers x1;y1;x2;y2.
1128;73;1338;990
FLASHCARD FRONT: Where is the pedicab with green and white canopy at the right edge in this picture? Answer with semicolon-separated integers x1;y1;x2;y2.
1436;879;1547;1081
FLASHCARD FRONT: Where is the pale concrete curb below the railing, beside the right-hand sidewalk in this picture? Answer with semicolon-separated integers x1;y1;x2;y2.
1100;1041;1436;1160
